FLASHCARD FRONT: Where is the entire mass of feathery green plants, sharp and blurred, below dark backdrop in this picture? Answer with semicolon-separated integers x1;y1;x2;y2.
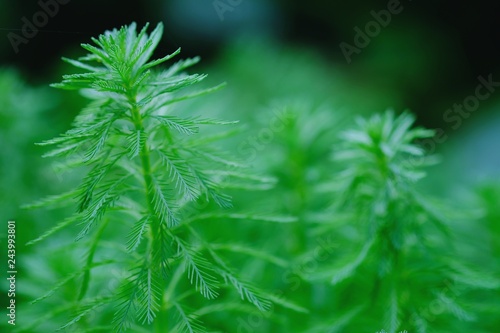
9;24;499;333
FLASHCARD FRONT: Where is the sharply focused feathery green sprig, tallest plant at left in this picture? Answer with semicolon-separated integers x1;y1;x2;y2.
30;24;282;332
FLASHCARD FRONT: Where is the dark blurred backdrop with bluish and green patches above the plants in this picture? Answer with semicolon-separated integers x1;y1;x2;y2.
0;0;500;179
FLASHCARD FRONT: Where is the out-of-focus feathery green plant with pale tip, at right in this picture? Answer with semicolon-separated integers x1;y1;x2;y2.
304;112;498;333
